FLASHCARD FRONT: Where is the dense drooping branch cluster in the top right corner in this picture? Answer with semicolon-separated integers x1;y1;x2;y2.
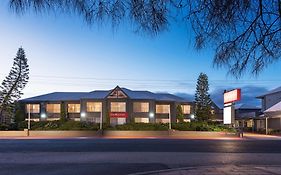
189;0;281;77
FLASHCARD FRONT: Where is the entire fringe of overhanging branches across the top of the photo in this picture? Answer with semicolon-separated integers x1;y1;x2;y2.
8;0;281;77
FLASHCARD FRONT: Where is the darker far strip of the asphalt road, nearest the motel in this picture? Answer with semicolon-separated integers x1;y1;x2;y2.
0;139;281;153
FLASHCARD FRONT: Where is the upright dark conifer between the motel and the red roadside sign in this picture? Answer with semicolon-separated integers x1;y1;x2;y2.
195;73;212;121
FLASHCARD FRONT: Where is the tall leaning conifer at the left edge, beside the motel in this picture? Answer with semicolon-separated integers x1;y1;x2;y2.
0;48;29;123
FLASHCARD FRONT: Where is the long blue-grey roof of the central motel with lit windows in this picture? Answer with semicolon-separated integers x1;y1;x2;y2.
20;86;188;103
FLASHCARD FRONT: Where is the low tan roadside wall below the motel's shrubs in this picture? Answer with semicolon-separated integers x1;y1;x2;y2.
0;129;237;139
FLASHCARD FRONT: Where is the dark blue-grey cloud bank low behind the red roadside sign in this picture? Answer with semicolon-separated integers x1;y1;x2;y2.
175;86;268;108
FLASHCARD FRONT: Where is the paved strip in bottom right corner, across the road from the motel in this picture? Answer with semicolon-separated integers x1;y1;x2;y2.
131;165;281;175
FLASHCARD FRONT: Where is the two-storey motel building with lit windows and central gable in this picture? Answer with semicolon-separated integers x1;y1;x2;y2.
20;86;193;125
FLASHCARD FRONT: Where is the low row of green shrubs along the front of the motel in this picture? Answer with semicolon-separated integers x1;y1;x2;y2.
12;120;235;132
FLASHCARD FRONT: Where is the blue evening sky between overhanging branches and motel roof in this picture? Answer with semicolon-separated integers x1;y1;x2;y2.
0;1;281;104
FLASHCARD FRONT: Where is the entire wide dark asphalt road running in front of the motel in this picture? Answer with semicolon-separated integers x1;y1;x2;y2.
0;139;281;175
